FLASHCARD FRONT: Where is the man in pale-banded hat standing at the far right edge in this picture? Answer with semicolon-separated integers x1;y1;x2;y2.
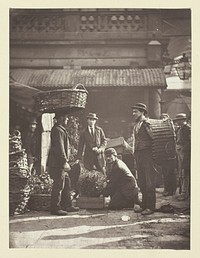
174;113;191;201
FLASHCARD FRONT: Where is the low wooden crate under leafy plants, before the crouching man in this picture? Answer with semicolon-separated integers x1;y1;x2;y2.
76;196;105;209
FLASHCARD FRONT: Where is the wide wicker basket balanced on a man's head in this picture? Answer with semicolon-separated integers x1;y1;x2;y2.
34;84;88;113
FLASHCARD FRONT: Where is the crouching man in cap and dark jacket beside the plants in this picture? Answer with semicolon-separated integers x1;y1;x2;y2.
103;148;141;210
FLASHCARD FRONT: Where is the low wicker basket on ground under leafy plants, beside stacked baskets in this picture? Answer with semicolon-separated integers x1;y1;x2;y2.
28;194;51;211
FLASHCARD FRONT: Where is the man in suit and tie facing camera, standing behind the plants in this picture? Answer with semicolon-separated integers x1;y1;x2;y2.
77;113;107;173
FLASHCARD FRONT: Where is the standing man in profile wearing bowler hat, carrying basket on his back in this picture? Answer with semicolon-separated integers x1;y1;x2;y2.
132;103;156;215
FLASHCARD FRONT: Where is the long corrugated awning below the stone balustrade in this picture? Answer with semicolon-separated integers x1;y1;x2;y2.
10;68;167;90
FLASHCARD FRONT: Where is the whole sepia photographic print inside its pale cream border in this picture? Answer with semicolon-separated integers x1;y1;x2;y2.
0;2;196;254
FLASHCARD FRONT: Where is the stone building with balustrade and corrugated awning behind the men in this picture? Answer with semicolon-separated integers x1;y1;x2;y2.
10;8;191;173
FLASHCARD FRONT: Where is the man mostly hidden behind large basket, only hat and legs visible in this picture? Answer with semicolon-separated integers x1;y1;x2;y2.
160;113;177;196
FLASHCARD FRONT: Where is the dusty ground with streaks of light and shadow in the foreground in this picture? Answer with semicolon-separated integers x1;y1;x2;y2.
9;189;190;250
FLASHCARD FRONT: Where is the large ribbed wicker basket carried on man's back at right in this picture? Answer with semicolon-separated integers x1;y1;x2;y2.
149;119;176;164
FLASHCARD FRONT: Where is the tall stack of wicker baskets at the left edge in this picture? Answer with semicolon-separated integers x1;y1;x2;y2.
9;131;30;215
